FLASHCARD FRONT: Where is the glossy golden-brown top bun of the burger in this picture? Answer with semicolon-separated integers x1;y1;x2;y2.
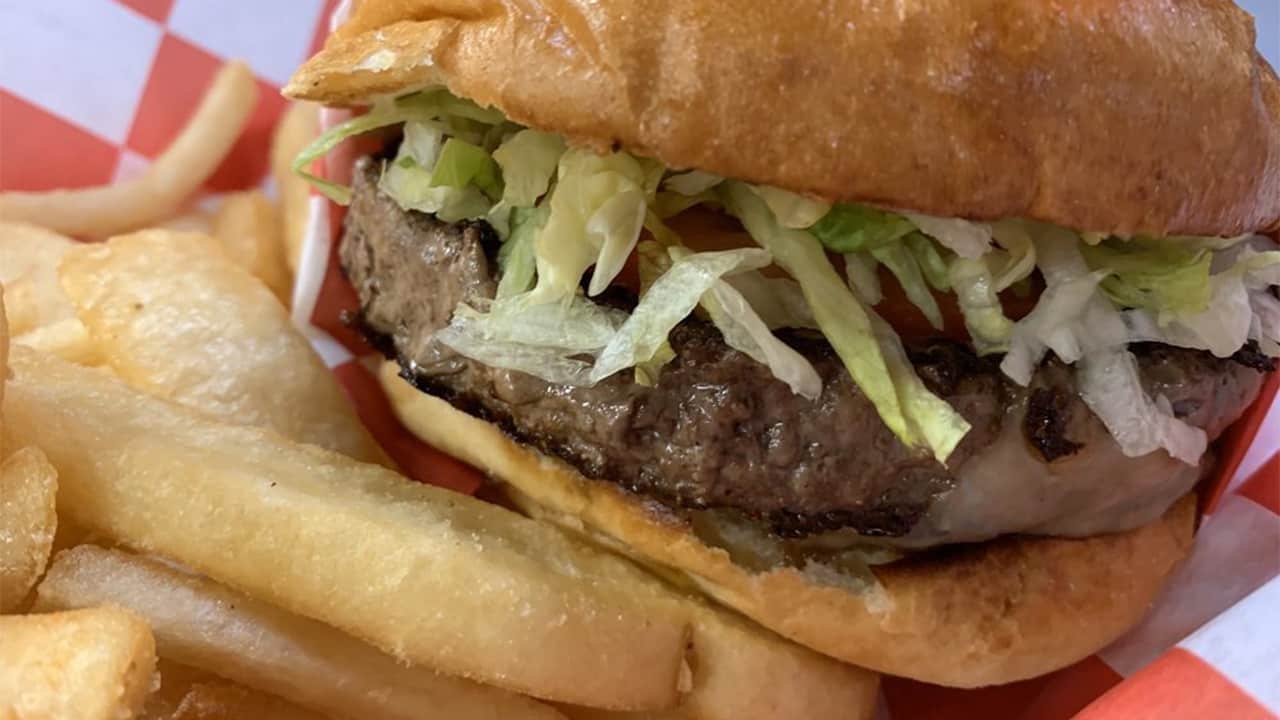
285;0;1280;236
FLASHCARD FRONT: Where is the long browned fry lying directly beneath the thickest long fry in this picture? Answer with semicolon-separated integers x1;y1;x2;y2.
35;546;559;720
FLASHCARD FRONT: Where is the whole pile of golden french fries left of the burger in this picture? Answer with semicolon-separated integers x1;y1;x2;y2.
0;64;876;720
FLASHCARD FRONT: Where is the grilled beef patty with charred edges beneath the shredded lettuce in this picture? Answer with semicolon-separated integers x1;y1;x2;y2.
340;159;1265;547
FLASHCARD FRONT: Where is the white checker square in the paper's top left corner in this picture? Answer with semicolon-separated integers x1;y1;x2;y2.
0;0;163;145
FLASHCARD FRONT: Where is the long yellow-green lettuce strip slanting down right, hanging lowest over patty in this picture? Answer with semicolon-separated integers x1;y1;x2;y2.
718;182;969;462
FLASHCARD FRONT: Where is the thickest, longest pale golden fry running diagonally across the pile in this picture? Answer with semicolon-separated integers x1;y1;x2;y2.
4;346;689;710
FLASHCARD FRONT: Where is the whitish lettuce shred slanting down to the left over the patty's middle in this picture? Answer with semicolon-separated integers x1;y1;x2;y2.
590;247;772;382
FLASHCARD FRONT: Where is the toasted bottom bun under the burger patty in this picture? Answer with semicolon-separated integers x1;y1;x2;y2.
381;363;1196;687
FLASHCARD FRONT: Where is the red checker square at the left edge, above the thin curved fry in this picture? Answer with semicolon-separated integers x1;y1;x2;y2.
0;91;120;190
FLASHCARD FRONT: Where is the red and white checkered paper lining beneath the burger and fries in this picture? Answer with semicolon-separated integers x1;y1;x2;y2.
0;0;1280;720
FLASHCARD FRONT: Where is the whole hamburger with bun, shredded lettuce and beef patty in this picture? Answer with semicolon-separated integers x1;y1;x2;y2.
285;0;1280;687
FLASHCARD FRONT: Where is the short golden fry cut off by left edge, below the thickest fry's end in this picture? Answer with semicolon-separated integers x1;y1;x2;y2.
0;447;58;612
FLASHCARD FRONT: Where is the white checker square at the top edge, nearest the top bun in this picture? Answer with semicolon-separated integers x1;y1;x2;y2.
169;0;324;85
